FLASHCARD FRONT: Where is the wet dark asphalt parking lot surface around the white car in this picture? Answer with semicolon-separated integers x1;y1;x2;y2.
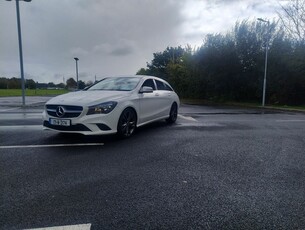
0;98;305;229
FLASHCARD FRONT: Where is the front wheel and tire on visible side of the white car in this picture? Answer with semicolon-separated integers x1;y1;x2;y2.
117;108;137;138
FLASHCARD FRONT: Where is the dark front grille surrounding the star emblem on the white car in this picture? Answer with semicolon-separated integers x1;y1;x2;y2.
46;105;83;118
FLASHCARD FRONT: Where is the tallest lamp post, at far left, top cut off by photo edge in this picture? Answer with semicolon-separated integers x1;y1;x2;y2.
6;0;32;106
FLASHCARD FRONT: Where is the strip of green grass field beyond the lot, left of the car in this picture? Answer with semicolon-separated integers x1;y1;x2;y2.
0;89;69;97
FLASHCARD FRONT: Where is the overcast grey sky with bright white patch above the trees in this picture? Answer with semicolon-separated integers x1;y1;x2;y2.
0;0;279;83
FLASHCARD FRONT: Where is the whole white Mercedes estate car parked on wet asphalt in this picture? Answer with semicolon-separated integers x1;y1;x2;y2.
43;75;180;137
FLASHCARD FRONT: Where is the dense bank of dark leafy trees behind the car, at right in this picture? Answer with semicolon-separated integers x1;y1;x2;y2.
137;20;305;105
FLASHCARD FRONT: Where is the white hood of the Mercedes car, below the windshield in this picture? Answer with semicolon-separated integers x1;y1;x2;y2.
47;90;131;106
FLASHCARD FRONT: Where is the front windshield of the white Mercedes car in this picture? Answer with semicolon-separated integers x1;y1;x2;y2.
88;77;140;91
